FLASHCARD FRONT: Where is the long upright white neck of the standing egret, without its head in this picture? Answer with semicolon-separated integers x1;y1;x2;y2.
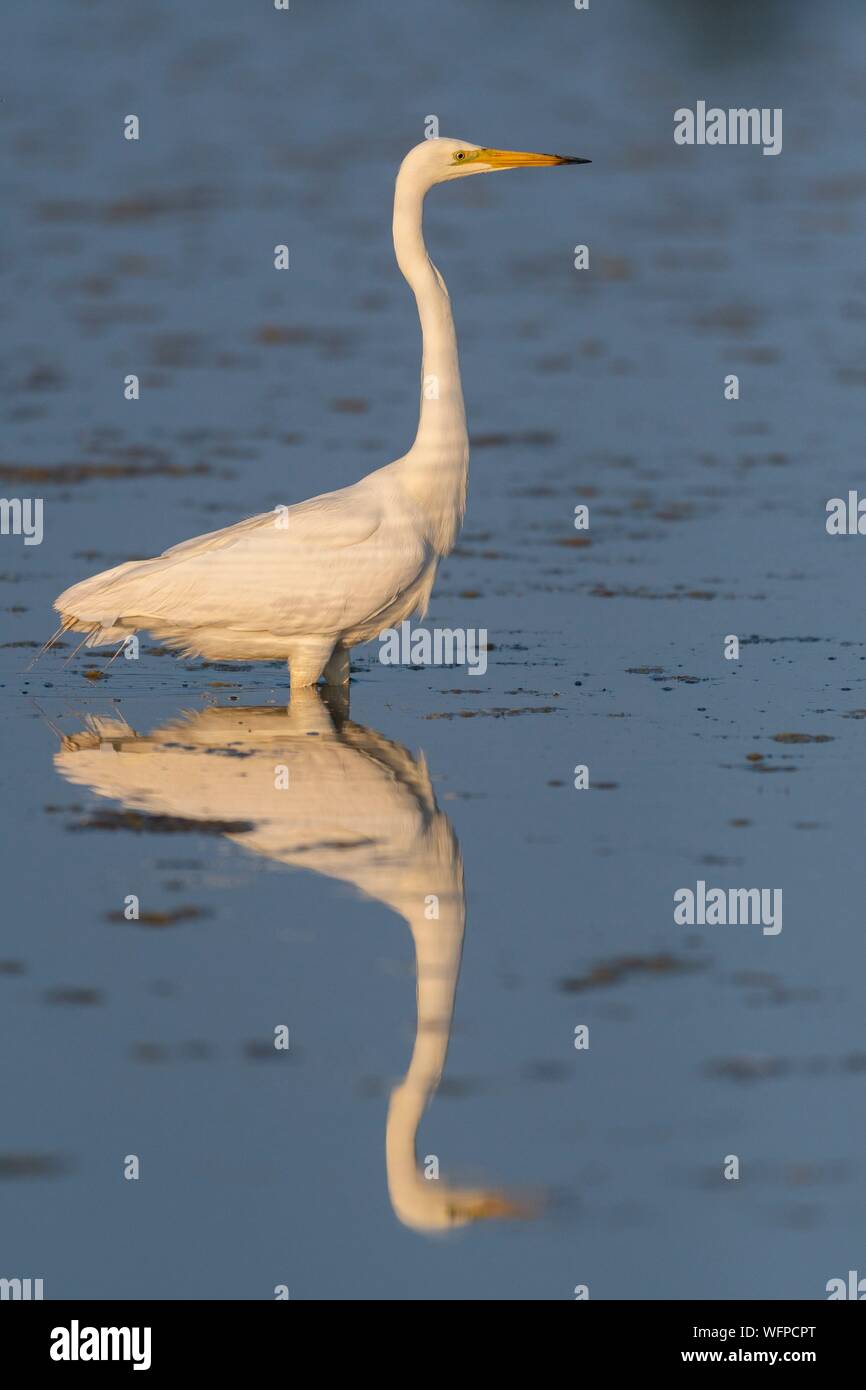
393;168;468;555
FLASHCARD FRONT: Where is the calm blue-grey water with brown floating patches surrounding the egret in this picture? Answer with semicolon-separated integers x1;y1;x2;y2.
0;0;866;1300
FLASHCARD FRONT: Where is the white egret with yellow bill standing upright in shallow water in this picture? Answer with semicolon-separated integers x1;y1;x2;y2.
46;139;589;689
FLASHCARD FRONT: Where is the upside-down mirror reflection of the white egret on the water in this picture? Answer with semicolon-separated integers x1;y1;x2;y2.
54;691;530;1230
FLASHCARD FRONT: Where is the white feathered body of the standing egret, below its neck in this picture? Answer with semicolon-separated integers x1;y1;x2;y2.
57;468;438;687
